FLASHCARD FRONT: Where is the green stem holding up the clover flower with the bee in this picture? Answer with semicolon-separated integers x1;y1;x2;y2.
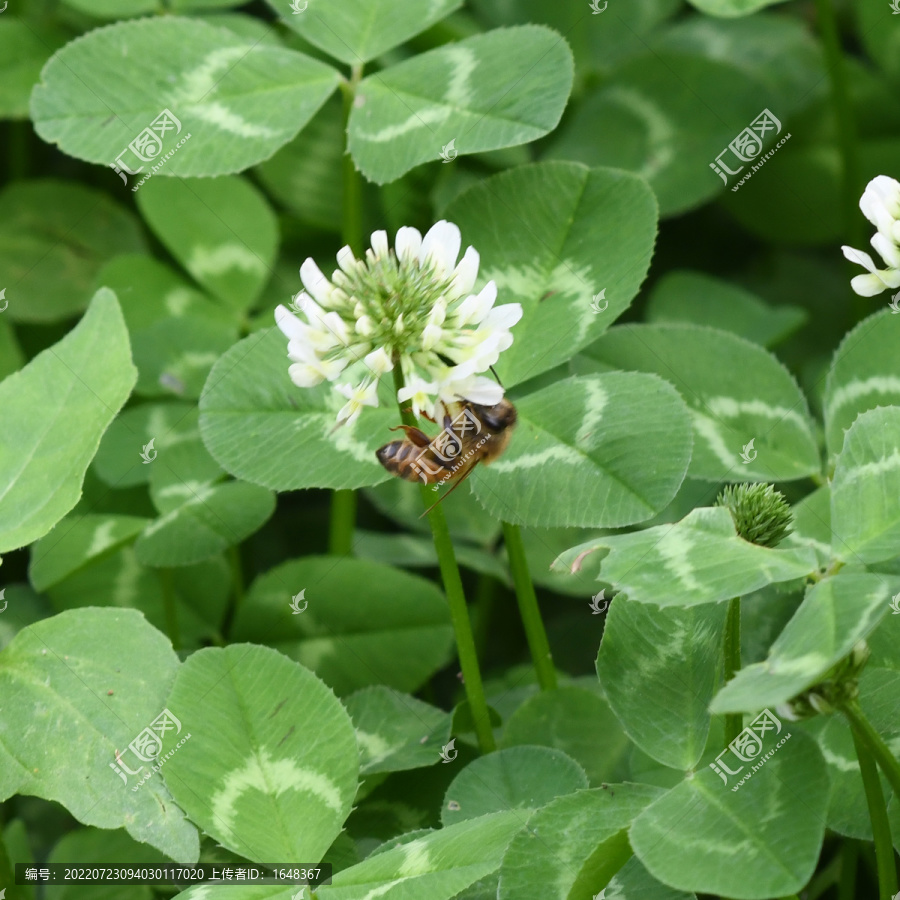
394;364;497;753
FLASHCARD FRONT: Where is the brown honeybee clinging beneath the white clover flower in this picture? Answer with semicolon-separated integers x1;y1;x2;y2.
376;398;517;515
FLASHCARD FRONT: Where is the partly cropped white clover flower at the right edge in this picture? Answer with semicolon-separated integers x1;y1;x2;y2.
841;175;900;297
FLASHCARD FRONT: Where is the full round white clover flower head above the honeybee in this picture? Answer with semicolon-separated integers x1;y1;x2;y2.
275;221;522;424
